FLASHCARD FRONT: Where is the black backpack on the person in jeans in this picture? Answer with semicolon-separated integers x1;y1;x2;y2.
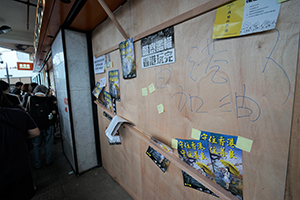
27;96;51;130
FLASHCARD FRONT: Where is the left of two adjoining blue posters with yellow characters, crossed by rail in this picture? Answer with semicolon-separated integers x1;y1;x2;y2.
177;139;216;196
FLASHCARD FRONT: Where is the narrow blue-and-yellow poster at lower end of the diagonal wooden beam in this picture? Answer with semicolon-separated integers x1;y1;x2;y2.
119;38;136;79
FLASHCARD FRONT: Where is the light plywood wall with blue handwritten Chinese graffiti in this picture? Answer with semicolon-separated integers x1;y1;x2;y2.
93;0;300;200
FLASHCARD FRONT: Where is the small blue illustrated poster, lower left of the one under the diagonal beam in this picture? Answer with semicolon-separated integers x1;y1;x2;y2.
108;69;120;101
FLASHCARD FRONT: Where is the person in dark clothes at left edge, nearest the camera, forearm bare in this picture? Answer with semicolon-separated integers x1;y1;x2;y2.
0;87;40;200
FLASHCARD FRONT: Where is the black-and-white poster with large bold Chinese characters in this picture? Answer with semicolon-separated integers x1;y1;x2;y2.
141;26;175;68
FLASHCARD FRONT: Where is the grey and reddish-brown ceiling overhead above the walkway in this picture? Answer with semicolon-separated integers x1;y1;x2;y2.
0;0;127;72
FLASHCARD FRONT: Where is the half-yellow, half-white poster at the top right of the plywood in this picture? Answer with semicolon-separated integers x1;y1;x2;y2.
213;0;280;39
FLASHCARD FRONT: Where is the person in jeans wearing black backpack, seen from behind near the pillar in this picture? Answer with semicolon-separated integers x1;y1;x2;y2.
26;85;56;169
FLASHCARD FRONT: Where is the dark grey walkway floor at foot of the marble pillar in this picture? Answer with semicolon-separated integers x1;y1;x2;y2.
32;135;132;200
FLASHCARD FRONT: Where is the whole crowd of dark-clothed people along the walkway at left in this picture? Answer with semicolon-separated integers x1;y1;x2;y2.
0;80;57;200
